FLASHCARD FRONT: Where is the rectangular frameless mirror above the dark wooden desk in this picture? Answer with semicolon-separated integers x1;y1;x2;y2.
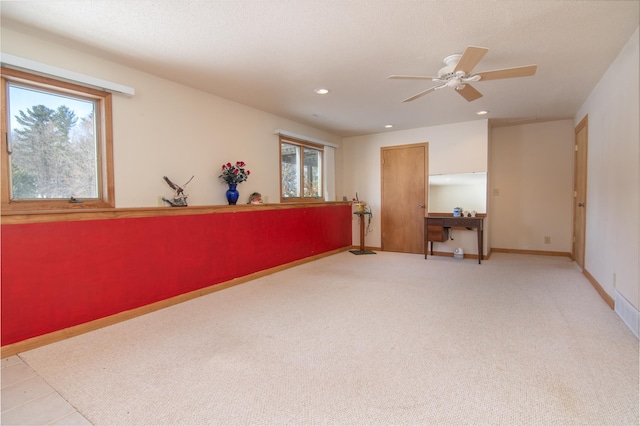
429;172;487;213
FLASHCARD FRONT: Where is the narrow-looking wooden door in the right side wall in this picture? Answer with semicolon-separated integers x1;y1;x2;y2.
572;116;589;269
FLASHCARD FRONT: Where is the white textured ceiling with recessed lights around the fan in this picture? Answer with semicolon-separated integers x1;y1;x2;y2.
0;0;640;136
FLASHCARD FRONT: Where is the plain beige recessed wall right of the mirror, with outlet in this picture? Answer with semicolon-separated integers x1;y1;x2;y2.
489;120;574;253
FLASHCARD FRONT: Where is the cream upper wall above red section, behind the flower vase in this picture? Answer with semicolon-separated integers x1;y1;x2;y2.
1;28;341;207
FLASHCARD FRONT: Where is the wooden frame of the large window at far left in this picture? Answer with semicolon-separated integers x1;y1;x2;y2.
0;67;115;210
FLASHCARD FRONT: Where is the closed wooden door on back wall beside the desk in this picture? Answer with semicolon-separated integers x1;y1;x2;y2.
380;143;429;253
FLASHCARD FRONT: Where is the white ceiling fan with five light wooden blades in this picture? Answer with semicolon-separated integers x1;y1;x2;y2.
387;46;538;102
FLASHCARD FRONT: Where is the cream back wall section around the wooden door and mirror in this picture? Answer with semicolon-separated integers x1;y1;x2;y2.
337;119;488;253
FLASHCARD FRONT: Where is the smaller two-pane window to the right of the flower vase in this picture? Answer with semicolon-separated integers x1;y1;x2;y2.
280;136;324;202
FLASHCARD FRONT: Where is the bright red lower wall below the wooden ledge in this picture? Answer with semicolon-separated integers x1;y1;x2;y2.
1;205;351;346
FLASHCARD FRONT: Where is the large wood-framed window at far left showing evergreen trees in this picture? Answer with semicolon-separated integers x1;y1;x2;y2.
0;68;114;210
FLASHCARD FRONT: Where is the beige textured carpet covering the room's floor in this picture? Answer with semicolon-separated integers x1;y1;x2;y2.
20;252;639;425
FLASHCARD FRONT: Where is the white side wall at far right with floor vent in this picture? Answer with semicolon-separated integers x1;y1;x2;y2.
574;29;640;309
